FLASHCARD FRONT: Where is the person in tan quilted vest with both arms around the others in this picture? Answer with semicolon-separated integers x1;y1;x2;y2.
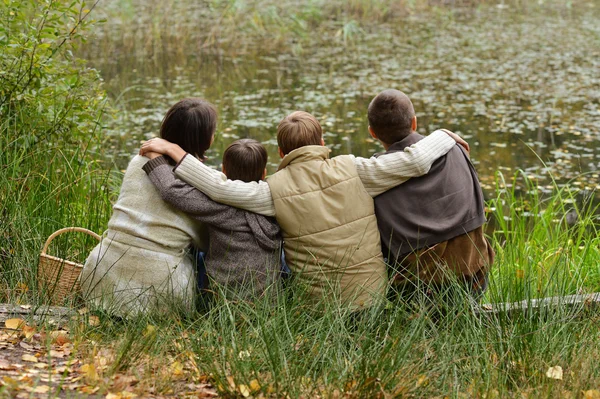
140;112;466;309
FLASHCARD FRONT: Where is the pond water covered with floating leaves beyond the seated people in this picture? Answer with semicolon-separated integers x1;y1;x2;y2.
82;1;600;198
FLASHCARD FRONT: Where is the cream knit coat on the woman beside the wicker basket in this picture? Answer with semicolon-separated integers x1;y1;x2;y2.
80;155;208;316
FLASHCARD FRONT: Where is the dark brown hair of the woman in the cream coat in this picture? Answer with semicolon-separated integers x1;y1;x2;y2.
160;98;217;158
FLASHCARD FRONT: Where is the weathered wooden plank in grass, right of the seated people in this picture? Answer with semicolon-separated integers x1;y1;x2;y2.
475;292;600;315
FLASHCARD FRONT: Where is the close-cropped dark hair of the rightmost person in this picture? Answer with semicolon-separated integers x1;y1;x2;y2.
367;89;415;144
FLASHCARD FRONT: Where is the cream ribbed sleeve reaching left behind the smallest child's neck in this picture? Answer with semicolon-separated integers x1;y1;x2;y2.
175;156;275;216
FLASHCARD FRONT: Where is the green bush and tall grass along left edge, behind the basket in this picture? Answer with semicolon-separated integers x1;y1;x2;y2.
0;0;110;301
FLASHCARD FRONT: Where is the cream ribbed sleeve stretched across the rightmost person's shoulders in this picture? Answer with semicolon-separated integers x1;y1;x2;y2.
354;130;456;197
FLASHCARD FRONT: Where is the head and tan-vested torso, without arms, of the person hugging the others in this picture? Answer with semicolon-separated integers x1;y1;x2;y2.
267;112;387;308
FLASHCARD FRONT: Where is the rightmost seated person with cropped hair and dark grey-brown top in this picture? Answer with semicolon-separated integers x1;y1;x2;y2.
369;90;494;292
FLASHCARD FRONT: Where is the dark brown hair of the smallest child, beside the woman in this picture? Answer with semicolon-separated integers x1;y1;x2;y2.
223;139;268;183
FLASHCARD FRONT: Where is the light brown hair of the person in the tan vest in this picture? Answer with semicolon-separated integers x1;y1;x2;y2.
277;111;323;155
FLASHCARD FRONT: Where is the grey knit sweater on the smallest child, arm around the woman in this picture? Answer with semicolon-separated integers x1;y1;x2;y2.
143;156;281;298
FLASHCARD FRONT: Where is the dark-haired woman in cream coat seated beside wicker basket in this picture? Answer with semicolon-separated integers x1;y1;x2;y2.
80;98;217;316
